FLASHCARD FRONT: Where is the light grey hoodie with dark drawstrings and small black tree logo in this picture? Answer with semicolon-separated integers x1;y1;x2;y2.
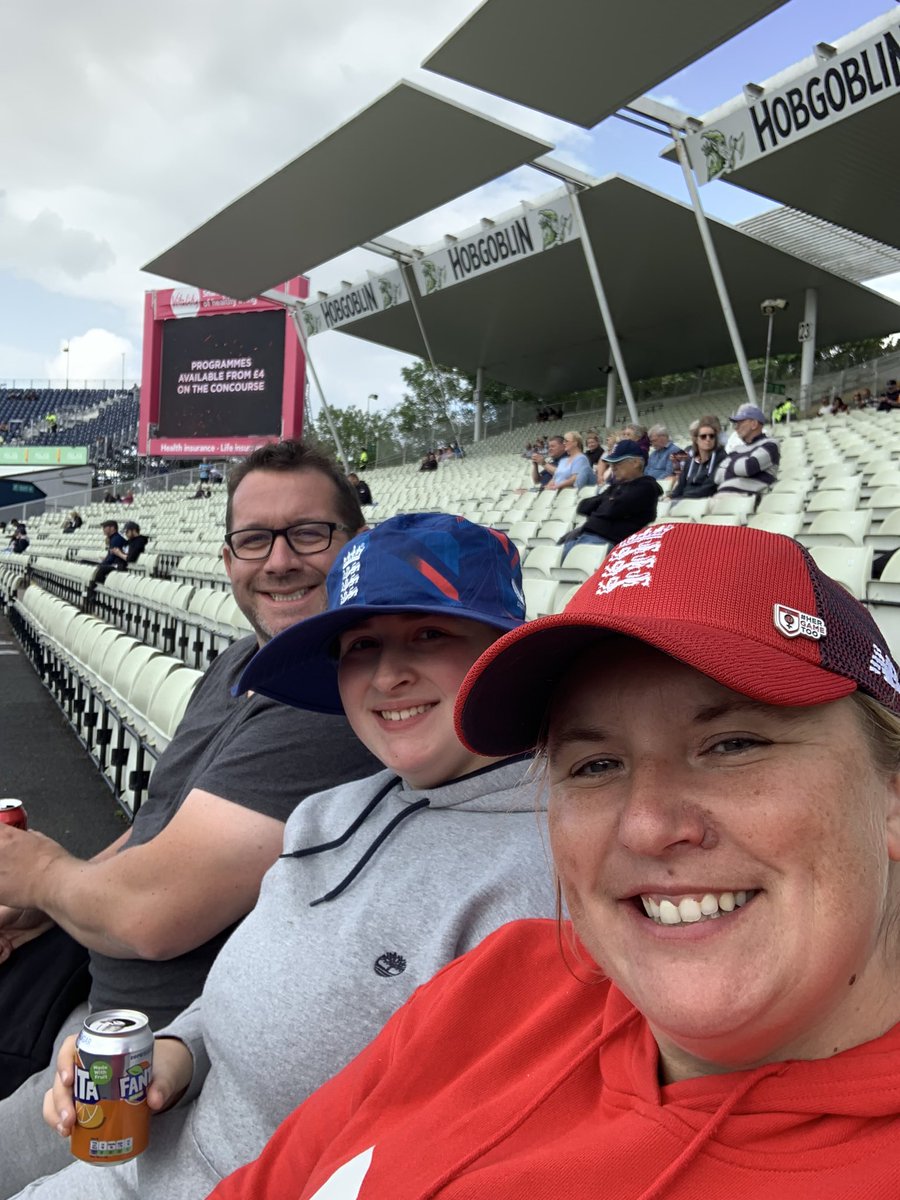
20;760;556;1200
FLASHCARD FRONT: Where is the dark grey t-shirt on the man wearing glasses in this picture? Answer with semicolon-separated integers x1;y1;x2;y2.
90;637;382;1028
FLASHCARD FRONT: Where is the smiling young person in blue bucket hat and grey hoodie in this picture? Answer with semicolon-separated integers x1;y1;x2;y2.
35;514;556;1200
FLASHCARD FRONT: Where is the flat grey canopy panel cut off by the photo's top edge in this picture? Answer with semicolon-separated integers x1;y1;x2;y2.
422;0;786;128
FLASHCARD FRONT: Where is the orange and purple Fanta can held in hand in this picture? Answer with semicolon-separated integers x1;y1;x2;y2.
72;1008;154;1165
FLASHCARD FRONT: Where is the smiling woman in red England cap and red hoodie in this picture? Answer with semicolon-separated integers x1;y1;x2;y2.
207;524;900;1200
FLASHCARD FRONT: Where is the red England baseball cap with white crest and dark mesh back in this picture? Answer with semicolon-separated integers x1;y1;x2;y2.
456;523;900;757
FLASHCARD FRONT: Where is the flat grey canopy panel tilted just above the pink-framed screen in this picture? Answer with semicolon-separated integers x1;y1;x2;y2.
144;80;552;300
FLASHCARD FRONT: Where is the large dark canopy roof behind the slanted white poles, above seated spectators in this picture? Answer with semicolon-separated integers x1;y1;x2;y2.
328;175;900;396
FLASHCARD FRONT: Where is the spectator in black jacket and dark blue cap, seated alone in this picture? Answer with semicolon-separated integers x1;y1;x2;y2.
563;438;662;558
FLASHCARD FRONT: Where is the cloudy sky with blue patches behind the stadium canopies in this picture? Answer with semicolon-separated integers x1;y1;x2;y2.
0;0;900;407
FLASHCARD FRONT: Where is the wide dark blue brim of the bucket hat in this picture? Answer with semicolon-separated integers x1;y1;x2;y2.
234;605;520;715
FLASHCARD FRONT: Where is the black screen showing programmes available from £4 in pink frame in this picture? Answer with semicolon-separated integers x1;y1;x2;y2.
157;310;284;438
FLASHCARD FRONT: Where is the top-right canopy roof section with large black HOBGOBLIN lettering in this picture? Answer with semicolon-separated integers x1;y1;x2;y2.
664;10;900;254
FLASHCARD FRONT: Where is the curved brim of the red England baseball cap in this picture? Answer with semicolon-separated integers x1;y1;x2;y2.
456;613;856;757
